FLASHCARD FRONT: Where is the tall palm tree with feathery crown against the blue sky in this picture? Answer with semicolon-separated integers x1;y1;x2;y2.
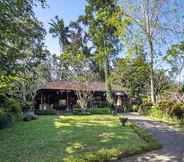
49;16;70;52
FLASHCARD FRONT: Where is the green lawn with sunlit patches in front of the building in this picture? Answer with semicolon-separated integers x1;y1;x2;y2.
0;115;160;162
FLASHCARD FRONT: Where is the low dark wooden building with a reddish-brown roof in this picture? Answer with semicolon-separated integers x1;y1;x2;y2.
34;80;127;111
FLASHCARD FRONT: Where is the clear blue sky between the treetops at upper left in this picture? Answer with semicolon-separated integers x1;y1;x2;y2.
34;0;85;54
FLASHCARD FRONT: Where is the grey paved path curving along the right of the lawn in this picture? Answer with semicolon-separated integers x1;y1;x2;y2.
117;114;184;162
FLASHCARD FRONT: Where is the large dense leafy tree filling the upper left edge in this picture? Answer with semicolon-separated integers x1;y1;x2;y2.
0;0;45;92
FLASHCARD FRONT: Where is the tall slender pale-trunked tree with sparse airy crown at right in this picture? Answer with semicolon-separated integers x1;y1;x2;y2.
122;0;183;103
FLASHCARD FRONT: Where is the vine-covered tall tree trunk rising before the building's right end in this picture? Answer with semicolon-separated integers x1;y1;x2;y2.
104;56;113;107
